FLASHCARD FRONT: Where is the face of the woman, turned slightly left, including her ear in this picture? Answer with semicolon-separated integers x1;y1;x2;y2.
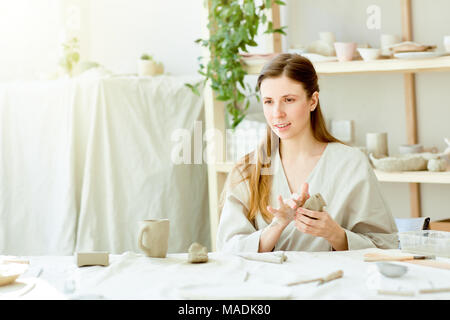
260;75;319;140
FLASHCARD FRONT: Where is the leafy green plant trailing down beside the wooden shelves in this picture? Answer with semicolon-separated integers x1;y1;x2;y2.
186;0;286;129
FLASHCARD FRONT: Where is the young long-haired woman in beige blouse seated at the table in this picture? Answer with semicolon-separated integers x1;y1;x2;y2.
217;54;398;252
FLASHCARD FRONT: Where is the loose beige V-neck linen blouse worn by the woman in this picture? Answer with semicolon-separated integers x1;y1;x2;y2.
216;142;398;252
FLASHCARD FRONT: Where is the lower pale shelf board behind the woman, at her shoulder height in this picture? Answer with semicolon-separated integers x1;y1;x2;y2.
214;162;450;184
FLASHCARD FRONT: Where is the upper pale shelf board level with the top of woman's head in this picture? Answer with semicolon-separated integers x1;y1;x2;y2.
244;56;450;75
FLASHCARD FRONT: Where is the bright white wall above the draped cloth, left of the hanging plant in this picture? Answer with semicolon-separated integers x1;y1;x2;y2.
0;0;272;81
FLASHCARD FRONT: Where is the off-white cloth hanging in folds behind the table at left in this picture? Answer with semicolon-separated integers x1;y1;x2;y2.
0;76;210;255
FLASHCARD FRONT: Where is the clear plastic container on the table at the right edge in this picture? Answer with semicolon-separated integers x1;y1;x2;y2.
398;230;450;258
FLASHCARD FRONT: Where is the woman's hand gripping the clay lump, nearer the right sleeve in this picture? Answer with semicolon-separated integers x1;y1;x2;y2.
295;208;348;250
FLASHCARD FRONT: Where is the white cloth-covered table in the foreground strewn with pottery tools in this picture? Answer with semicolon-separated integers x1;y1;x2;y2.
0;249;450;300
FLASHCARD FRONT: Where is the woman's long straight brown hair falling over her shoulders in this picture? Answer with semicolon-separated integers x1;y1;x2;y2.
220;53;342;224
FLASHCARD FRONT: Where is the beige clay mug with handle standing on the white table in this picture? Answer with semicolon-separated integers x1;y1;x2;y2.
138;219;169;258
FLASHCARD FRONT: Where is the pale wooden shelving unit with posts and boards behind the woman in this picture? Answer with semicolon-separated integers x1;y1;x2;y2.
205;0;450;250
